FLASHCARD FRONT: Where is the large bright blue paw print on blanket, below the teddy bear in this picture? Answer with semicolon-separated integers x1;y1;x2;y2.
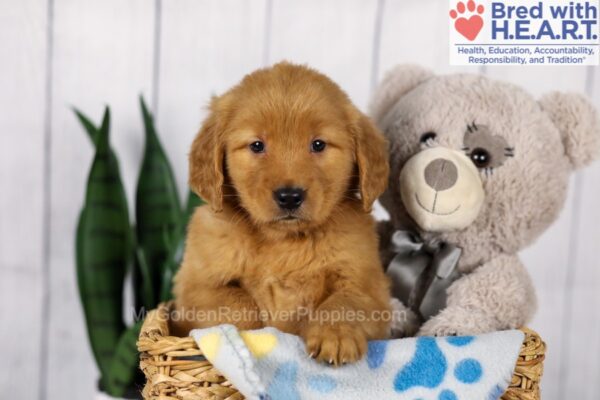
392;336;483;400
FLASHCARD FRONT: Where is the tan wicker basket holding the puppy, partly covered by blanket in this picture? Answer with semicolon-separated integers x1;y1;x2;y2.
137;303;546;400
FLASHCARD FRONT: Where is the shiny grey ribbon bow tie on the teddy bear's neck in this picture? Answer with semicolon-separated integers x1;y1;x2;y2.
386;231;462;321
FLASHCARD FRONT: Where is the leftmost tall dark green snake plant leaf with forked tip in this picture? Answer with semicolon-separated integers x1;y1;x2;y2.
76;109;131;384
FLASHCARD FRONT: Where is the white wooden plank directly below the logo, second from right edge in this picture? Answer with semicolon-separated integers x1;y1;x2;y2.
487;66;585;400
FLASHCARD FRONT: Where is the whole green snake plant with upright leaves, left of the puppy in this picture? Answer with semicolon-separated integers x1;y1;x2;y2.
75;97;202;398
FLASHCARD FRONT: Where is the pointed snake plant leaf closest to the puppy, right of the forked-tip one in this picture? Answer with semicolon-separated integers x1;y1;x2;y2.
136;97;182;293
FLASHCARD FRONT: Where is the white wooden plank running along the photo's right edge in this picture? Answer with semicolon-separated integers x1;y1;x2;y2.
558;67;600;400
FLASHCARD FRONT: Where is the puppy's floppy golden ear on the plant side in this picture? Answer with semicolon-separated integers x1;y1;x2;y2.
189;99;225;212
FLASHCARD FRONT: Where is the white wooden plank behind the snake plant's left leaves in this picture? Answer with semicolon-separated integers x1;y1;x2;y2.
46;0;154;399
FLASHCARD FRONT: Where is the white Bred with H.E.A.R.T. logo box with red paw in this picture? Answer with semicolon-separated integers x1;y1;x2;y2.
449;0;600;65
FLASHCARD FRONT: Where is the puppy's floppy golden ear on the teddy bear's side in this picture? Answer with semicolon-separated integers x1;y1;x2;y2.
353;114;389;212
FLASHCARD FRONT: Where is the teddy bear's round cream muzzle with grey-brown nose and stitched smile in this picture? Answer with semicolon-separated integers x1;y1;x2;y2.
400;147;485;232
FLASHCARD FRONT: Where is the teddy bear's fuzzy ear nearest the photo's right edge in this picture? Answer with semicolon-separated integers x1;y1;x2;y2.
540;92;600;168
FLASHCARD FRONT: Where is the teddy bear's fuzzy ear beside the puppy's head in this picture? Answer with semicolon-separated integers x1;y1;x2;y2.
369;64;433;122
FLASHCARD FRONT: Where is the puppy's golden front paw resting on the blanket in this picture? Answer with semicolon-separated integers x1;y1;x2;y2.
302;324;367;366
